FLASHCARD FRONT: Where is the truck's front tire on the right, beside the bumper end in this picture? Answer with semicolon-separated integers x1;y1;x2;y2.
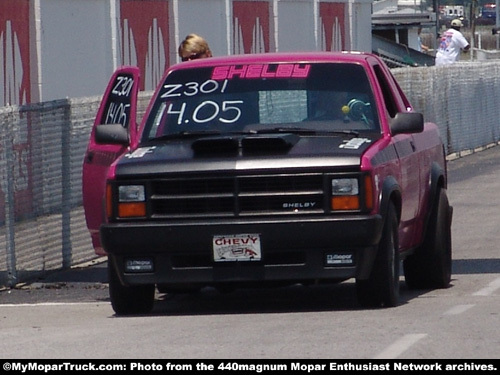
356;203;400;307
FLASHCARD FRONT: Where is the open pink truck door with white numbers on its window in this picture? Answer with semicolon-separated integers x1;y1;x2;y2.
82;67;140;255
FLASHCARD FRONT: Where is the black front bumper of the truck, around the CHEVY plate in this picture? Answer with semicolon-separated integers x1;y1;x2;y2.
100;215;383;285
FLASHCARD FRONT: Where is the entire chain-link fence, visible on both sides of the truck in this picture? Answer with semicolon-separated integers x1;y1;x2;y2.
0;61;500;287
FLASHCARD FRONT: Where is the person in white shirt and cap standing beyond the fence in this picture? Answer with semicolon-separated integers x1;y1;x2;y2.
435;19;470;65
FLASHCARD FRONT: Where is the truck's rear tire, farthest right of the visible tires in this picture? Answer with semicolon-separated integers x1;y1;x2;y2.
403;188;452;289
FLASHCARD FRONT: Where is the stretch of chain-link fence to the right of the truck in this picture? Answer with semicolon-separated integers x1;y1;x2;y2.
392;60;500;155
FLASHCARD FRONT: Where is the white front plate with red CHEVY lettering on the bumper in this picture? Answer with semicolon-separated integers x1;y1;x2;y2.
213;234;262;262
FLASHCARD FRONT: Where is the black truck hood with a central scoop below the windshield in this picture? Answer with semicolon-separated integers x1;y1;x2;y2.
115;133;381;177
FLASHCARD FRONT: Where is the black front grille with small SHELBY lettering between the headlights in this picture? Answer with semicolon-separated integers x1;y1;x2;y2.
148;173;328;219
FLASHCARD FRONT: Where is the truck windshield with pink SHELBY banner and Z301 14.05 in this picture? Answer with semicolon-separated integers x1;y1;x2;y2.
143;63;380;141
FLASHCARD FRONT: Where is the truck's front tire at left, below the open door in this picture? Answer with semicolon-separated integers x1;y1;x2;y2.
108;261;155;315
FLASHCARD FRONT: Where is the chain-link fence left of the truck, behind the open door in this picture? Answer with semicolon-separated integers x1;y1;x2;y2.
0;92;152;287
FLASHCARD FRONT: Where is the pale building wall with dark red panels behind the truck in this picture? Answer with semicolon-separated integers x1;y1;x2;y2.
0;0;372;107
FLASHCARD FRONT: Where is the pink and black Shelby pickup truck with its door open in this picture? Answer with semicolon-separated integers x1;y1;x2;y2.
83;53;452;314
